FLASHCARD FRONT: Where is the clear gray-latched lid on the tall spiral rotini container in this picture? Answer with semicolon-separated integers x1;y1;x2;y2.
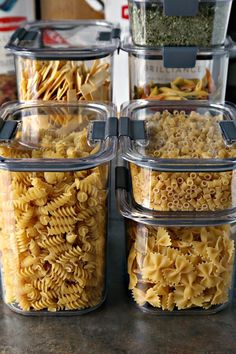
0;101;117;172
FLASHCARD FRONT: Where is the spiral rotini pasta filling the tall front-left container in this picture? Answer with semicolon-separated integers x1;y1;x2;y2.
0;116;108;311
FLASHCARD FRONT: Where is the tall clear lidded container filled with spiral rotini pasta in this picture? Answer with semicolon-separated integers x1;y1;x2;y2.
0;102;117;314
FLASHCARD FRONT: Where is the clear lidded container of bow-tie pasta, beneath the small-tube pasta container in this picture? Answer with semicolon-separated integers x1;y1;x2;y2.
117;167;235;315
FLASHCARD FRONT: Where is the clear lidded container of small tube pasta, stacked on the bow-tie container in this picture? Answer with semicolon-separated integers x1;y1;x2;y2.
120;100;236;217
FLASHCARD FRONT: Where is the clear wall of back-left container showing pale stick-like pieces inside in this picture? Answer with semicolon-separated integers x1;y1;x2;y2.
15;55;113;102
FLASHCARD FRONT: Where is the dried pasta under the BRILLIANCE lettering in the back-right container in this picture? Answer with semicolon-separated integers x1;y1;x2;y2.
133;69;216;101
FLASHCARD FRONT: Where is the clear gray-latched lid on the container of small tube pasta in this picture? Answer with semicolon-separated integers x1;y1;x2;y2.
119;100;236;172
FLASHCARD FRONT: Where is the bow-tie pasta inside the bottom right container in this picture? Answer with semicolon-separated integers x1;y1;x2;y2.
128;221;234;311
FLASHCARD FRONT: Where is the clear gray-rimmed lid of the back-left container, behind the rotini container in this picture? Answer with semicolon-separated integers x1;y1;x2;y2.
6;20;120;60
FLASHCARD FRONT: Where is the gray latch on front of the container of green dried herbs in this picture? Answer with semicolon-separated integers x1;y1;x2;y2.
163;0;199;17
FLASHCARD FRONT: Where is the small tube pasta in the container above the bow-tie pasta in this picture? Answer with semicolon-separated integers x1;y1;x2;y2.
130;111;236;211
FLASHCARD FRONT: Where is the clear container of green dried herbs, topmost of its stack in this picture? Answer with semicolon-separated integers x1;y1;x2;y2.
128;0;232;47
